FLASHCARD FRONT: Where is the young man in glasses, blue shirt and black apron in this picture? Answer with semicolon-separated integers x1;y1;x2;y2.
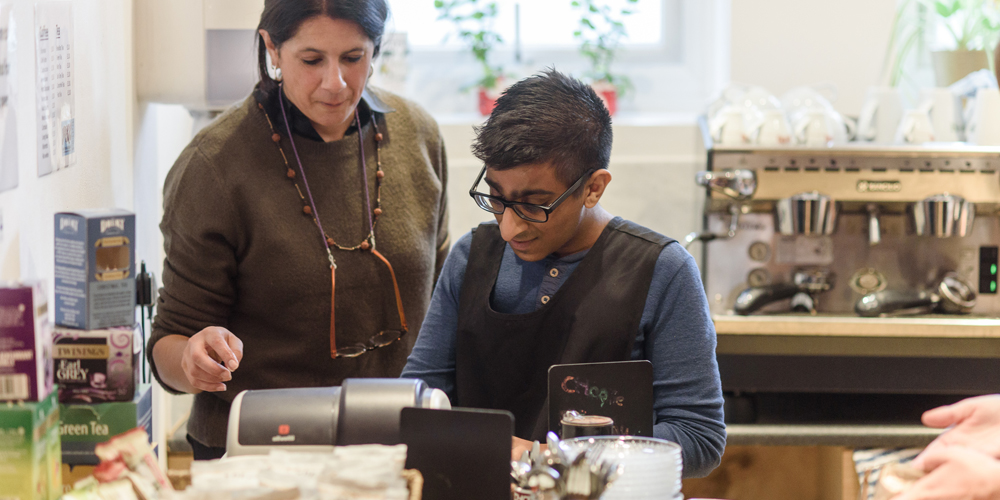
403;71;726;477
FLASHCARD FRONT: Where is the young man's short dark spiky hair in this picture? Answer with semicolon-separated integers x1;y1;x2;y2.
472;69;612;186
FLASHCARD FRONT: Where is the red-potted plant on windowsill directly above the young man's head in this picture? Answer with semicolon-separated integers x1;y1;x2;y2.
570;0;639;114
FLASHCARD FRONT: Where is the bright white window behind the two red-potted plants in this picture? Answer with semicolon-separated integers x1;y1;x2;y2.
376;0;730;116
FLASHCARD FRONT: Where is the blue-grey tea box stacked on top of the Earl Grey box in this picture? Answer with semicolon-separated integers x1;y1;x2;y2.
55;209;135;330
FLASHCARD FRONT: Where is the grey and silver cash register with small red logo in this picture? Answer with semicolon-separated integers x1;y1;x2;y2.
226;378;451;456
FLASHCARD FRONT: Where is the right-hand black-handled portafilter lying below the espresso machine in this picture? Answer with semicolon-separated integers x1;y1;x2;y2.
854;273;976;318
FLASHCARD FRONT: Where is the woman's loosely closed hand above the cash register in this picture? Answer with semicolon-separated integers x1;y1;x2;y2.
181;326;243;392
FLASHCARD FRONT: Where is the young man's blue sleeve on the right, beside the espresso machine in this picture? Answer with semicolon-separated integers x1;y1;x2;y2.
633;244;726;477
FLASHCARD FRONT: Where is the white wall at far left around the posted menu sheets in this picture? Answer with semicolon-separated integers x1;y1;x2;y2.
0;0;135;282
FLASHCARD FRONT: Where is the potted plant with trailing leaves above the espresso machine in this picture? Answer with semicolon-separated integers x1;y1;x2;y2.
884;0;1000;87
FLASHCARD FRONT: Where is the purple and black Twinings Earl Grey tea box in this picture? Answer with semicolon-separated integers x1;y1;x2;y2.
52;327;139;404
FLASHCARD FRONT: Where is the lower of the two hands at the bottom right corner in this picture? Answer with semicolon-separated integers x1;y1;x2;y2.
892;446;1000;500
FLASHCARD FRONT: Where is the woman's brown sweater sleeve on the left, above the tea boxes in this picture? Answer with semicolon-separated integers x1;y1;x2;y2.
146;143;239;393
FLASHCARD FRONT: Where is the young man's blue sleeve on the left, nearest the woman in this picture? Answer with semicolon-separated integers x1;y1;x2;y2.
400;232;472;403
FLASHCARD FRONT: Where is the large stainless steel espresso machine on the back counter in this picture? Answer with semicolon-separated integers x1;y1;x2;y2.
688;124;1000;316
